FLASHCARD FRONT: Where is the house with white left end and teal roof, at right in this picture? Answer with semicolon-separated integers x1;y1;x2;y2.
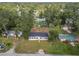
59;34;76;42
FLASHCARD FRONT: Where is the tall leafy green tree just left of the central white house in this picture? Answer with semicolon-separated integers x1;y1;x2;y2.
15;5;34;38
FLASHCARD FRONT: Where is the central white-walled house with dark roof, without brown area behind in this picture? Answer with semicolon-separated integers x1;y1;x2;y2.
29;32;48;40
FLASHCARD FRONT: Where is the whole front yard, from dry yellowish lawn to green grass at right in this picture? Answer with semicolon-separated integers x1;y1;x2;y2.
15;40;79;55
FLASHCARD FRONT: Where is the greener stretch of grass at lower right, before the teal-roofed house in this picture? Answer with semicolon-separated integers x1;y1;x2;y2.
48;42;79;55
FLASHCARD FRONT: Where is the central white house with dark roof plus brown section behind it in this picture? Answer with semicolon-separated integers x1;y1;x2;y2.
29;27;48;40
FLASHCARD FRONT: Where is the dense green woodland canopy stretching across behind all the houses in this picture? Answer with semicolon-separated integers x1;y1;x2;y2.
0;3;79;38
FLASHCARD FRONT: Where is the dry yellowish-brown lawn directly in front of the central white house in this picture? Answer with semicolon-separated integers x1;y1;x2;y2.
15;40;50;53
